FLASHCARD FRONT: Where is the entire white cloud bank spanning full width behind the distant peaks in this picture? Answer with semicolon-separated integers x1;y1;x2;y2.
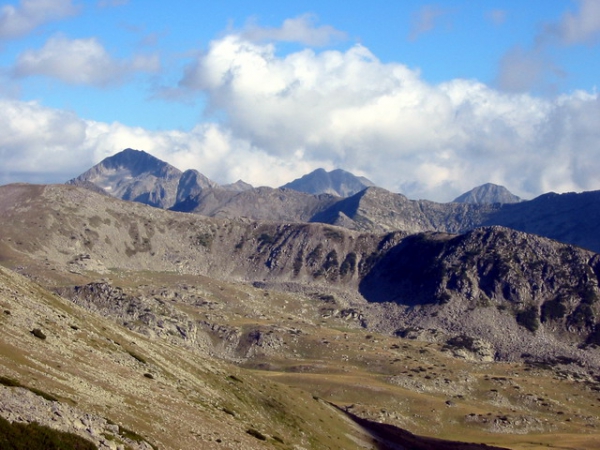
0;30;600;201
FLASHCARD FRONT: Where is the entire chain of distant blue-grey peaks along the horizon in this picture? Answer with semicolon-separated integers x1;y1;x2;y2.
69;149;600;252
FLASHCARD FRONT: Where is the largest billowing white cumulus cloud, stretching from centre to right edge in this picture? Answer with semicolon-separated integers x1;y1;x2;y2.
182;35;600;199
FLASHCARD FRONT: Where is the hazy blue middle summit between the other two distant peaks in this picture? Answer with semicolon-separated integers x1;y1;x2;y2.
281;169;375;197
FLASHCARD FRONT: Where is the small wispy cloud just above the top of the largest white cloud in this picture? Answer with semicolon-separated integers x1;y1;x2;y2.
242;14;346;47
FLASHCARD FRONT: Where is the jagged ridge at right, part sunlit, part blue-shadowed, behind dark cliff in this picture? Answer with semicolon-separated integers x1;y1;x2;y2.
311;188;600;252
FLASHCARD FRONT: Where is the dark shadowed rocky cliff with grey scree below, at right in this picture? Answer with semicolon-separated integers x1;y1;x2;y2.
359;227;600;358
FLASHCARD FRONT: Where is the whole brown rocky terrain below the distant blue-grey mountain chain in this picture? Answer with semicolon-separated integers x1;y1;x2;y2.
0;185;600;449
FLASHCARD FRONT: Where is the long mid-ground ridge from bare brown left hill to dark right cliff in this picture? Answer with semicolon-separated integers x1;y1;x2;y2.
0;185;600;370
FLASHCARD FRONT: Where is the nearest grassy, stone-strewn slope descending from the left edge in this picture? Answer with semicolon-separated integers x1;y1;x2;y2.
0;268;394;450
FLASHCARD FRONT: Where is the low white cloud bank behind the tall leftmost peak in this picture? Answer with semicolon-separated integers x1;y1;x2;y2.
0;100;312;186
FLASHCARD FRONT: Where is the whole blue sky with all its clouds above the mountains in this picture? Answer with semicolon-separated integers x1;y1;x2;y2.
0;0;600;202
